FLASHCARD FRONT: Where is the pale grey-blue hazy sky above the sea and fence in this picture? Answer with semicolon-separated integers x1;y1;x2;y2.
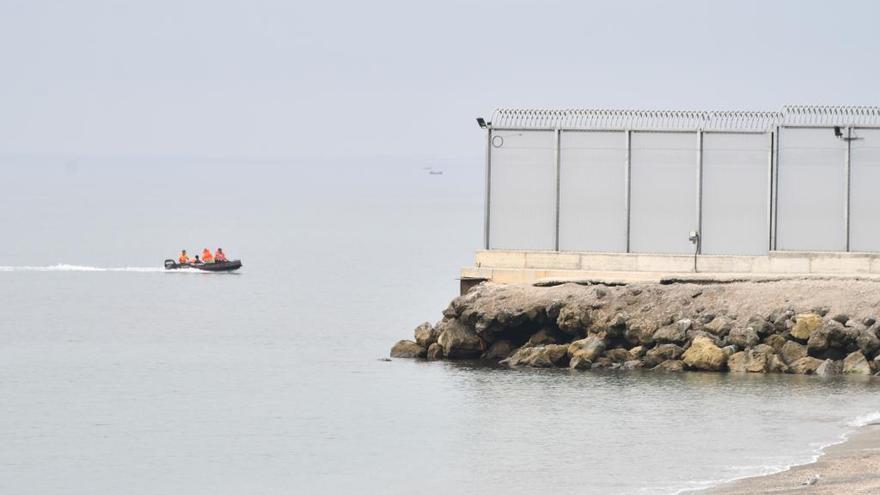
0;0;880;159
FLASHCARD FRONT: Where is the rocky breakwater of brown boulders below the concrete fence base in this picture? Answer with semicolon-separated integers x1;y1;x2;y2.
391;280;880;375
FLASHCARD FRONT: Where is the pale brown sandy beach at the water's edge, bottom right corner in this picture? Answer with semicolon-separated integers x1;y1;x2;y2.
698;423;880;495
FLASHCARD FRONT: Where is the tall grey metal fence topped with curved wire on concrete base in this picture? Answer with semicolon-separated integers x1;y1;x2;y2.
485;103;880;255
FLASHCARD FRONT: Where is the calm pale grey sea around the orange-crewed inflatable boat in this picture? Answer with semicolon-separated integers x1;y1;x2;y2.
0;156;880;494
